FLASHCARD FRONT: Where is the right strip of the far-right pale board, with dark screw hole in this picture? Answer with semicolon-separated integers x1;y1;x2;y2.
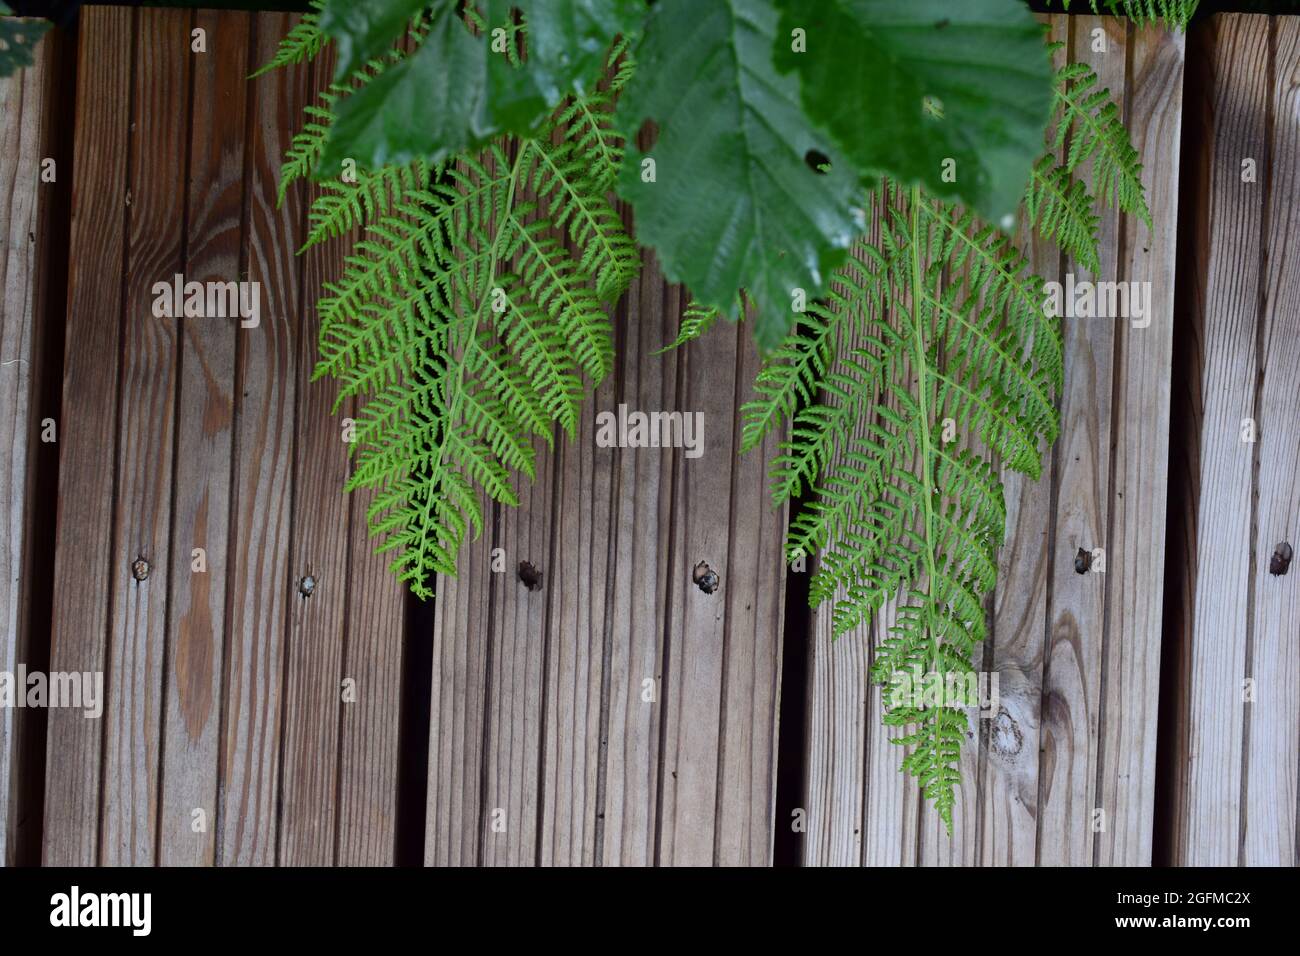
1240;17;1300;866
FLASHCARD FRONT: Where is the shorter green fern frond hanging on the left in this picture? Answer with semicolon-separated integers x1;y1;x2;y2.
312;95;640;596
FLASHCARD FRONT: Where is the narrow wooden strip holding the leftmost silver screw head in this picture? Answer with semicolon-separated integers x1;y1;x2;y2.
100;10;191;866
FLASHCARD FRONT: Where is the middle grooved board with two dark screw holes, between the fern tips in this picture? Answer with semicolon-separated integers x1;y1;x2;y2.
425;251;784;865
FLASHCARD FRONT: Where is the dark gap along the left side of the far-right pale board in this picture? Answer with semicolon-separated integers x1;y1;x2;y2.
1151;11;1213;866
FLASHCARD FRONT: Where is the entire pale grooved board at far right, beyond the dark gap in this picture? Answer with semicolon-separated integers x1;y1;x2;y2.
1171;14;1300;866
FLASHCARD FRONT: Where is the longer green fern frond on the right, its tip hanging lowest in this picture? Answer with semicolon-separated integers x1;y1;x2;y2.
742;185;1062;827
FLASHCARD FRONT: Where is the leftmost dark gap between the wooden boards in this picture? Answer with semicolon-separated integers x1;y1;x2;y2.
9;30;77;866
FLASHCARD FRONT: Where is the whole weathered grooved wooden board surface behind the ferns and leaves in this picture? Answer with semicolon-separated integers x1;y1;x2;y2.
0;8;1300;865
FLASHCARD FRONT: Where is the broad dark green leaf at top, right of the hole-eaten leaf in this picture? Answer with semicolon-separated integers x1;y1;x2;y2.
775;0;1052;228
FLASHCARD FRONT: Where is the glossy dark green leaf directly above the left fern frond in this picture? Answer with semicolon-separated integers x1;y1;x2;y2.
321;0;644;169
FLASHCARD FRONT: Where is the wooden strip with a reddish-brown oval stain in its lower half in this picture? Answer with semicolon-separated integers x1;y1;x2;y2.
159;5;250;866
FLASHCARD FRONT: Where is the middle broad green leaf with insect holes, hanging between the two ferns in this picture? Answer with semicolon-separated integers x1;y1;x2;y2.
616;0;865;349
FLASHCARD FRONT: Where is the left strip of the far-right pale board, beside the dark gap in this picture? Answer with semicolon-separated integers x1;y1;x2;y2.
1175;16;1253;865
